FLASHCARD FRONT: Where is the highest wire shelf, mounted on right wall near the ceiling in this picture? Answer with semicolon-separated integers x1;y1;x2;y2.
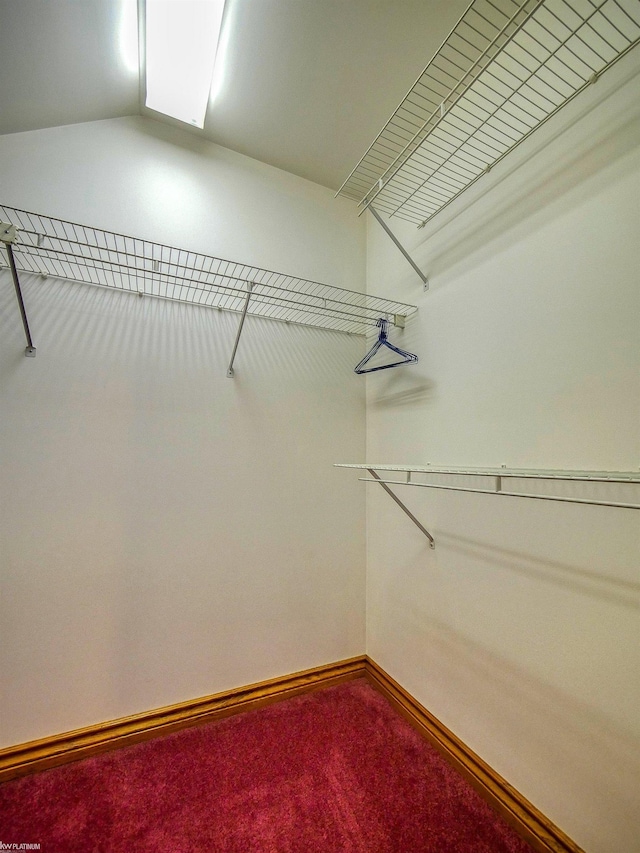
337;0;640;226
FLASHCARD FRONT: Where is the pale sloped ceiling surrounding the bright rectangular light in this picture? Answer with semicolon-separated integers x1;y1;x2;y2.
0;0;468;189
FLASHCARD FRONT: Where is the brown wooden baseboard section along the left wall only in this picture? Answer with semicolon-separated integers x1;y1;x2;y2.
0;656;365;782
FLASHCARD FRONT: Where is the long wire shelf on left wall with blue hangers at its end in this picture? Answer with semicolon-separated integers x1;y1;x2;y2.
0;205;417;335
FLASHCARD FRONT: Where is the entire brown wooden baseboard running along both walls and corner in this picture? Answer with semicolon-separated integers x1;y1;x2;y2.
0;656;584;853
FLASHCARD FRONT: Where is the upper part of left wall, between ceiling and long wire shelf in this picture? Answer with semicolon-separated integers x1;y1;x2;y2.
0;116;365;290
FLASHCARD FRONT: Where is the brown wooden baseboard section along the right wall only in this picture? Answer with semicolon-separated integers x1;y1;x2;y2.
365;657;584;853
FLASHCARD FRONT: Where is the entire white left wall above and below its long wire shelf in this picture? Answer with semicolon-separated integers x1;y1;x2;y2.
0;119;365;745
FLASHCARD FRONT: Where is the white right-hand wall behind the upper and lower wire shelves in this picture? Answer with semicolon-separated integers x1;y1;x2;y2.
364;51;640;853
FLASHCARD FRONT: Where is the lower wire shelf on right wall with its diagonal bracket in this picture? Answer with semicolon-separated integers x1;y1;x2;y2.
335;463;640;548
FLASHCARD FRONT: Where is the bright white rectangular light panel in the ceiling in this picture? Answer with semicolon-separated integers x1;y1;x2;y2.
145;0;224;127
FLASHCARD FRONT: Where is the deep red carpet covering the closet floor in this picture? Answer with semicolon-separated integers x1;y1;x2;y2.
0;680;531;853
